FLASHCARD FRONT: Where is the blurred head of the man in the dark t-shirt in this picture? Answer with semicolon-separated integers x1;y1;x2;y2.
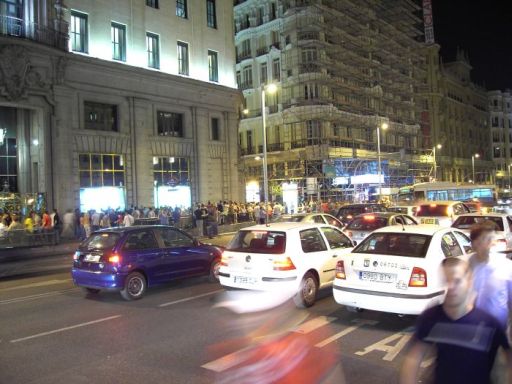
442;257;473;307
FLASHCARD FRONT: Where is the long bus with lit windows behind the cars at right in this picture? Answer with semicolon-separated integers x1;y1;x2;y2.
398;182;497;206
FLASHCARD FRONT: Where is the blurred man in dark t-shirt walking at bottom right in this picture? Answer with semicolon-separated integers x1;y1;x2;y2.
400;258;512;384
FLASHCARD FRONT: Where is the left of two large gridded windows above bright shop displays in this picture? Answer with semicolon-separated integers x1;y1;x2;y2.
78;153;125;188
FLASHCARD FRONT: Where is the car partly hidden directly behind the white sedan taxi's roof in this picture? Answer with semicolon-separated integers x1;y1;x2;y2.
343;212;418;243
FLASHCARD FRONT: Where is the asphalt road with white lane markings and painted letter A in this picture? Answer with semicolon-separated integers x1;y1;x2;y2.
0;232;432;384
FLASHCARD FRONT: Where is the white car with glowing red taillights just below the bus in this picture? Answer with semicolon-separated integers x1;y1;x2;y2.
414;201;471;227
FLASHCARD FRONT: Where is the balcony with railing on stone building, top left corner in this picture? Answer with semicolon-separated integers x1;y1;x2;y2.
0;15;69;51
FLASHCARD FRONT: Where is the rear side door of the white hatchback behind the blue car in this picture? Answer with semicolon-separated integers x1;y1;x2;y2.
300;228;330;286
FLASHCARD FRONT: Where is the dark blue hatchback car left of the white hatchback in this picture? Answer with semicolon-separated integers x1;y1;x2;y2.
71;225;222;300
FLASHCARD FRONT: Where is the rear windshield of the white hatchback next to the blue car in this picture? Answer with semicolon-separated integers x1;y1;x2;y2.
226;230;286;254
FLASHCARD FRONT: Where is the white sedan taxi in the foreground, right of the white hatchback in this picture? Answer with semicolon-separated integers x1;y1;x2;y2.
333;225;471;315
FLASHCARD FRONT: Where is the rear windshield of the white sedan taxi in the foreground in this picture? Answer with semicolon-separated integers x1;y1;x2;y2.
352;233;432;257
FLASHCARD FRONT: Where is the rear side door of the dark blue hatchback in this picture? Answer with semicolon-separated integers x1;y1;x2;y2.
121;229;165;285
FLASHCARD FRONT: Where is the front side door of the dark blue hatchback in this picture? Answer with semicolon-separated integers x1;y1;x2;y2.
156;228;209;279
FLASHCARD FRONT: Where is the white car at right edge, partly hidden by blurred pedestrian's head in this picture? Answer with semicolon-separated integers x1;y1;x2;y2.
452;213;512;252
